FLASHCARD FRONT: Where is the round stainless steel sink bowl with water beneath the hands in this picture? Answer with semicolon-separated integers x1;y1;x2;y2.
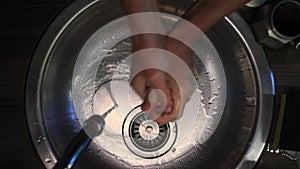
26;0;274;169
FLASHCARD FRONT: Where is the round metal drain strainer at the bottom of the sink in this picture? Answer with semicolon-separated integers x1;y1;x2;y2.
122;107;177;158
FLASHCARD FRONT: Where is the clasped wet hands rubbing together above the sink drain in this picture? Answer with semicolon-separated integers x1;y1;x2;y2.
131;70;192;123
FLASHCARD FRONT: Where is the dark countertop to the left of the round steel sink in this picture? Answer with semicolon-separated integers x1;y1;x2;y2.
0;0;69;169
